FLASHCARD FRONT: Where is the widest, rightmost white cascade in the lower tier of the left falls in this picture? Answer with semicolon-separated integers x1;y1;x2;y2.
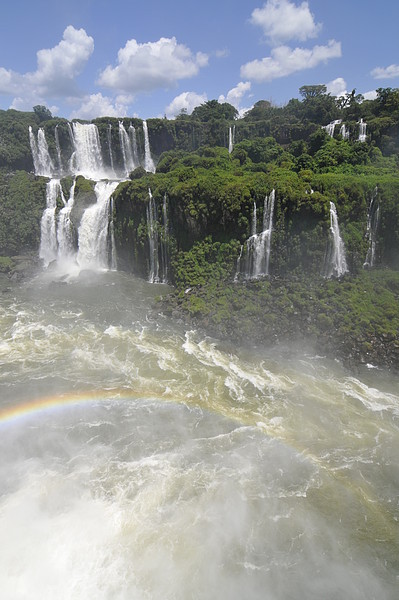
77;181;118;269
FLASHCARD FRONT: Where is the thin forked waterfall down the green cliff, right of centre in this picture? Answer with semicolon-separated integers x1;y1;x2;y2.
242;190;275;279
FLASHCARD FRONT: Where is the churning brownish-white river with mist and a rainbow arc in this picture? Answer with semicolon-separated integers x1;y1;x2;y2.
0;272;399;600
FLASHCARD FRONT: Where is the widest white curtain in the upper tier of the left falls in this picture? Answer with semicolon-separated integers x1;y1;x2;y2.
70;122;111;181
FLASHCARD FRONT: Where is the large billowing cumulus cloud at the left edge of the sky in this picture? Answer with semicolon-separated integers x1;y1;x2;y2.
0;25;94;103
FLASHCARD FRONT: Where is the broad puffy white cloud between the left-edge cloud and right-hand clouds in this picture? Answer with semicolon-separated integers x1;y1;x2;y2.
98;37;208;93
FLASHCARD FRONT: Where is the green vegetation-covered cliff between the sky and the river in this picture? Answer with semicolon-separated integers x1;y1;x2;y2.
0;86;399;368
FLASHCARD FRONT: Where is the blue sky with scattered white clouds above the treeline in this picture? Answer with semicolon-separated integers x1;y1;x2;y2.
0;0;399;119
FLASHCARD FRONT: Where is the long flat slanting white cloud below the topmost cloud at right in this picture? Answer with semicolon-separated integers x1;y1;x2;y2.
241;40;341;83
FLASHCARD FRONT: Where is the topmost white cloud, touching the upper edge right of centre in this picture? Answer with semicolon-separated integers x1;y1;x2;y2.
251;0;321;45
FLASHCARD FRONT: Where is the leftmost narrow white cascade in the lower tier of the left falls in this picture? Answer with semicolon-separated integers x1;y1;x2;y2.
39;179;65;267
